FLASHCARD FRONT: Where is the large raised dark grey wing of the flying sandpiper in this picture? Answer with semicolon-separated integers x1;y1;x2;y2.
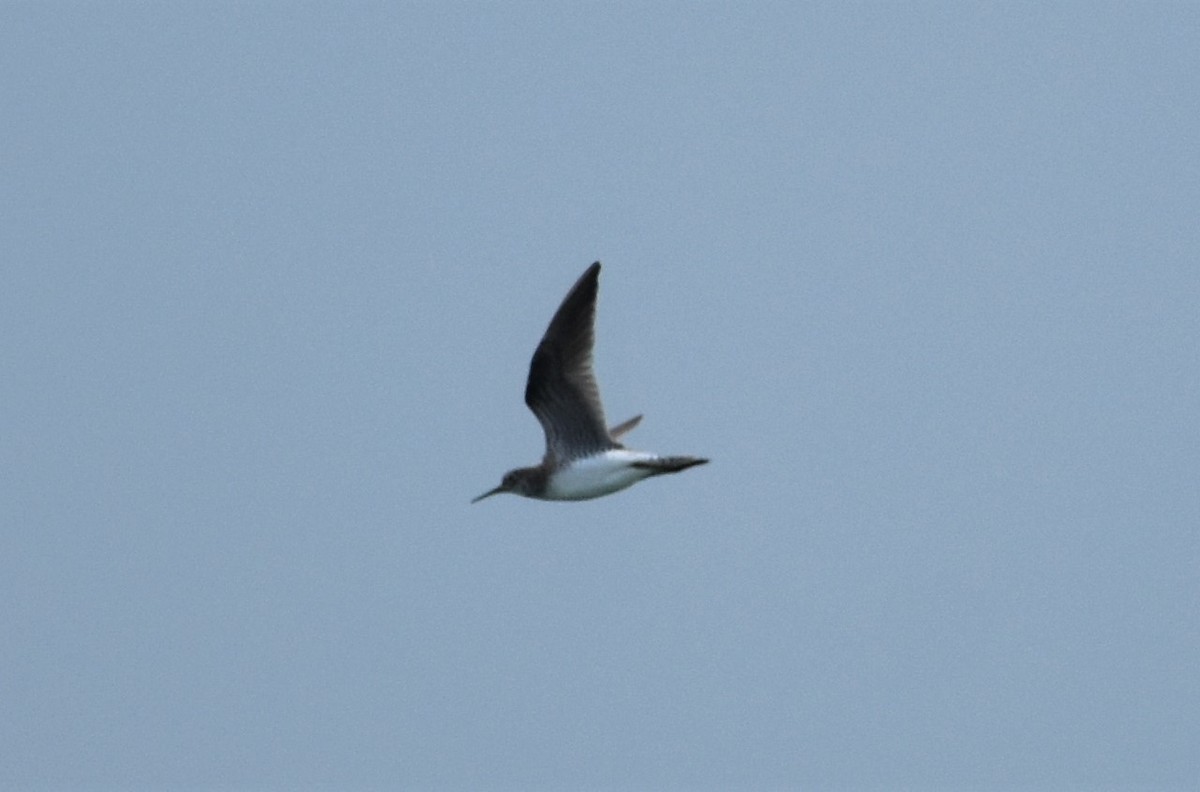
526;262;620;461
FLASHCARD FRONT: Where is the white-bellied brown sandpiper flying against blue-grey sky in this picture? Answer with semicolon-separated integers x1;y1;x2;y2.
472;262;708;503
